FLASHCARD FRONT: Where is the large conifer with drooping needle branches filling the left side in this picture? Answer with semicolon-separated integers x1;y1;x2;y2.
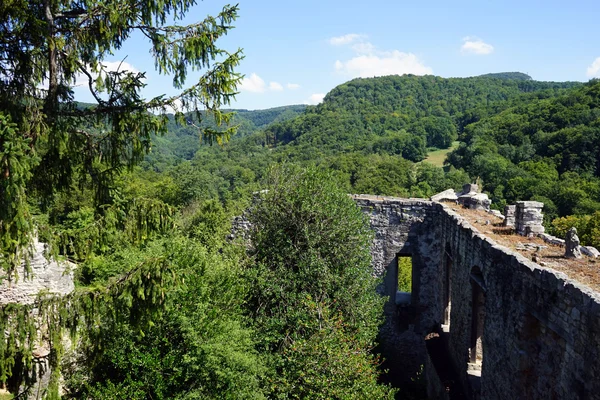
0;0;242;398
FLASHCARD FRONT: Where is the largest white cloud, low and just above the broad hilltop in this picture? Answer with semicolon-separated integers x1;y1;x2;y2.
335;50;433;78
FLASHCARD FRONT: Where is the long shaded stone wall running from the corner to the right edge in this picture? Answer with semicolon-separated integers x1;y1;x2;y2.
436;205;600;399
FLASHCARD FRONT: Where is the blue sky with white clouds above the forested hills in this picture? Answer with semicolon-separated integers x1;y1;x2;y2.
77;0;600;109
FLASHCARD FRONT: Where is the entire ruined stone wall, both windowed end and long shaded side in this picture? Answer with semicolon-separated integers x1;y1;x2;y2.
355;196;600;399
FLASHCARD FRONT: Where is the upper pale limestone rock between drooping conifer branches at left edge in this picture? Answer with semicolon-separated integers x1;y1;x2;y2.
0;238;75;304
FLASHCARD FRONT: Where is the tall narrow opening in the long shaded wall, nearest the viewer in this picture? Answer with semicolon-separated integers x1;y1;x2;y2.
469;267;485;371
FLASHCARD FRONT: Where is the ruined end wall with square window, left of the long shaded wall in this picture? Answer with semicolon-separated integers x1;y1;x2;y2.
354;196;441;381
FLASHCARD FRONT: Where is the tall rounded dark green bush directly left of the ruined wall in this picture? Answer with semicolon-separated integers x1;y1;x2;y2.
247;168;390;398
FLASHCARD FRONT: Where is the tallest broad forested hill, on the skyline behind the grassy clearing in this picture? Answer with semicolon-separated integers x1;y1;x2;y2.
266;73;580;161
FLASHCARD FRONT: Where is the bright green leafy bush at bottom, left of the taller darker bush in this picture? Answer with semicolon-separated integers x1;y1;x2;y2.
67;236;265;399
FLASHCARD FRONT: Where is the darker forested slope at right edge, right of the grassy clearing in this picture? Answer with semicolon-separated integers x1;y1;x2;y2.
449;81;600;227
